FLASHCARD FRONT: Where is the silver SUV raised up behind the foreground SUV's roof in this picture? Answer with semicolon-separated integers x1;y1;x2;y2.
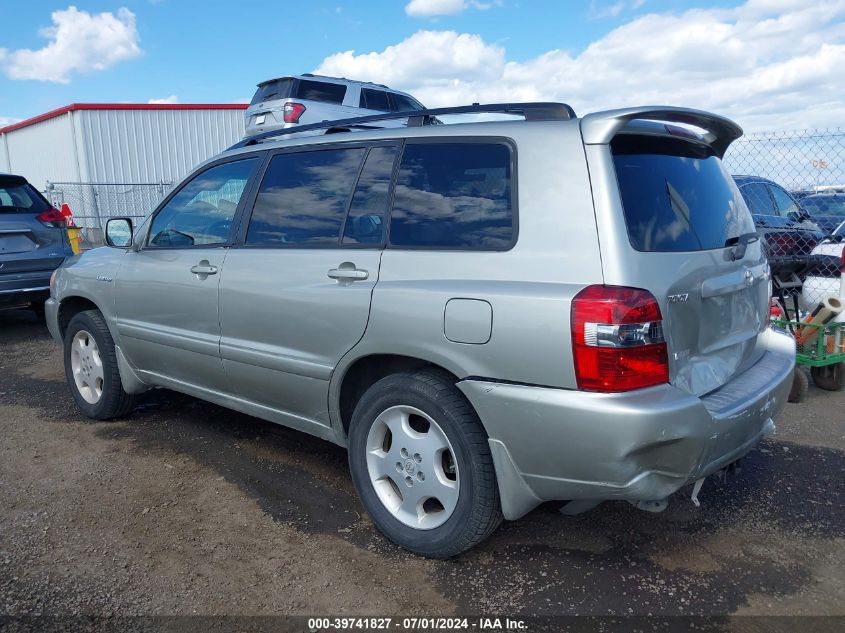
245;73;423;136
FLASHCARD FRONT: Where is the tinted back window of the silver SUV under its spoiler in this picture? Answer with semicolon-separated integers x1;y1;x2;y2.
611;135;754;252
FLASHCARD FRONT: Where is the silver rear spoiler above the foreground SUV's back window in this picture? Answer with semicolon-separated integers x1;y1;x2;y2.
581;106;742;158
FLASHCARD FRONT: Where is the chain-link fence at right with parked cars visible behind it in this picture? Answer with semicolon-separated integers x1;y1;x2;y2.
725;128;845;320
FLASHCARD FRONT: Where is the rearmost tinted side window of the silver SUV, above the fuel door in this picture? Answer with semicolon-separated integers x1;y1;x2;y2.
389;143;514;250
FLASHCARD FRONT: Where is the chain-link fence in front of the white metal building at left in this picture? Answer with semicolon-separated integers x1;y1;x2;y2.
44;182;173;247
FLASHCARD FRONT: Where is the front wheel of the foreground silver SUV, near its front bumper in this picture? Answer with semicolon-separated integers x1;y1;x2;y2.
64;310;135;420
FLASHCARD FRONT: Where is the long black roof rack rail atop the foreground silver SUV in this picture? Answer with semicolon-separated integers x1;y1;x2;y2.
229;102;575;150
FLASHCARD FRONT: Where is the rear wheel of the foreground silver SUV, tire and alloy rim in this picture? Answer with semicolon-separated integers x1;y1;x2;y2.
349;369;502;558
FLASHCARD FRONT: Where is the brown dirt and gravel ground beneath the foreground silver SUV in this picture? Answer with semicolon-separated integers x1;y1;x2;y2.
0;311;845;615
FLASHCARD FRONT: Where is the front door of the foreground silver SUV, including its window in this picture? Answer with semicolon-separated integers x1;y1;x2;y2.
115;157;260;392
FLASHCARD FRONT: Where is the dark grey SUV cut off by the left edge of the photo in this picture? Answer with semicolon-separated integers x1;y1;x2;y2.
0;174;73;311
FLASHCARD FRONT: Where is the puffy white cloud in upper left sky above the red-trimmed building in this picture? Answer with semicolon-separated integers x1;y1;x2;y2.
0;6;142;83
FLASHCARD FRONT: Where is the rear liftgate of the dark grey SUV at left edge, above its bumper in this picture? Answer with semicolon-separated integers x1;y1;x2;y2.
0;175;70;277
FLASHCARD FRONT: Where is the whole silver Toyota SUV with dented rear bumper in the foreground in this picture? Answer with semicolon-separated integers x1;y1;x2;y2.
47;104;794;557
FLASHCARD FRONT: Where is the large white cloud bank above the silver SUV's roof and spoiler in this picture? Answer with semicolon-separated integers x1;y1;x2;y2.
316;0;845;129
